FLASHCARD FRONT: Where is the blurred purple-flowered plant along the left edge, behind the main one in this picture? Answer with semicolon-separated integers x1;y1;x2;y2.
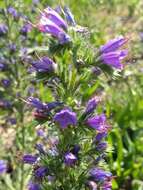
0;0;44;190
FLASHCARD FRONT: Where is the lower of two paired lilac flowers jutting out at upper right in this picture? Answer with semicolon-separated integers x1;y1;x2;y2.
100;50;128;70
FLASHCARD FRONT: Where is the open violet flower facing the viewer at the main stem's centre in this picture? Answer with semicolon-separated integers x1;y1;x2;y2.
54;109;77;129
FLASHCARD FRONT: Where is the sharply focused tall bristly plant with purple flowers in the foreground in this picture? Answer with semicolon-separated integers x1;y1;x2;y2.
22;4;127;190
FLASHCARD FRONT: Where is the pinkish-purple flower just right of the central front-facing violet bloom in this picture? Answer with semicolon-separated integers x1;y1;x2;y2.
87;114;107;132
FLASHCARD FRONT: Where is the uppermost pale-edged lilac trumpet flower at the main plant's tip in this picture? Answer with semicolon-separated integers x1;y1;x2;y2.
42;7;67;29
